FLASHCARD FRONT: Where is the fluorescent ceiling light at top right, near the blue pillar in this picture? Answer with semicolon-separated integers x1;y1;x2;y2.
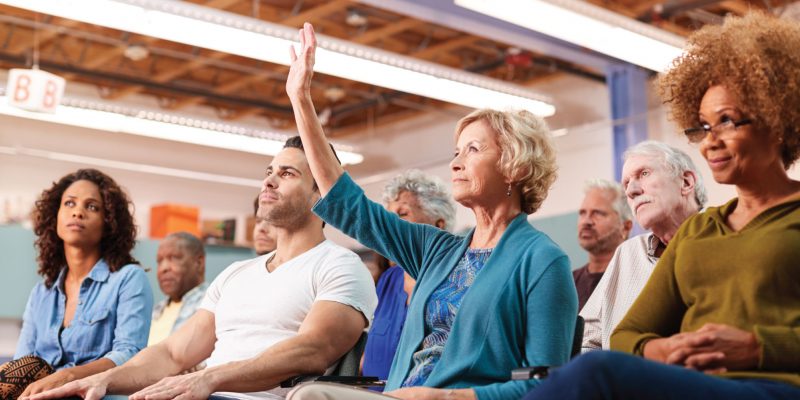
455;0;685;72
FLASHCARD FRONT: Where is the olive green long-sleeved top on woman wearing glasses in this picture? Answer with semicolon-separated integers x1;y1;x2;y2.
611;197;800;386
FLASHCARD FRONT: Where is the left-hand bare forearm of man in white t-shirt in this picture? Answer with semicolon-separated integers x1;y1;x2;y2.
104;344;182;394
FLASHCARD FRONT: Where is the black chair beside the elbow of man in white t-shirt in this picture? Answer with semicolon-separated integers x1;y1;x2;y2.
281;332;383;388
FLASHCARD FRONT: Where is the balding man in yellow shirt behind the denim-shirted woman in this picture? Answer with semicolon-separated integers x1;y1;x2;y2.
147;232;208;346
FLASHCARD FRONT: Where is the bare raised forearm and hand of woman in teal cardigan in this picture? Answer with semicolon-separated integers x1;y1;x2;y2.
286;23;344;196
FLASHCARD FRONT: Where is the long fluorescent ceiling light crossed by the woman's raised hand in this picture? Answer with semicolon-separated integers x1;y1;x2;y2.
0;0;555;117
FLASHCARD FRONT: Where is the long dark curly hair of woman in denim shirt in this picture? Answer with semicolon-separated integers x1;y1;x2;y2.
33;168;139;288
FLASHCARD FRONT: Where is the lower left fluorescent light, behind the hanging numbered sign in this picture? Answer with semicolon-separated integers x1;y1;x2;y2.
0;96;364;165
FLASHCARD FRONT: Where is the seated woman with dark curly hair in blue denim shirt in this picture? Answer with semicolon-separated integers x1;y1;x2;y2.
0;169;153;399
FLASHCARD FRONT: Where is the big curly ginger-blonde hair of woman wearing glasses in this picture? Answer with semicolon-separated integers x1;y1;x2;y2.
658;12;800;169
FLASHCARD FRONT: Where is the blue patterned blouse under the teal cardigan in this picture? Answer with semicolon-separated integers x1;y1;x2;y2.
402;249;492;387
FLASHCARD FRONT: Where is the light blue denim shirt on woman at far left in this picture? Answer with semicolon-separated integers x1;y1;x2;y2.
14;259;153;370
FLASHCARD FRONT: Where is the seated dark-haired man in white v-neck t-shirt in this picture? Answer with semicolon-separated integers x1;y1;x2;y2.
32;137;377;400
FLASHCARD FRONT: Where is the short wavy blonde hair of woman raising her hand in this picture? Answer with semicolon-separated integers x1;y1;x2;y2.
456;109;558;214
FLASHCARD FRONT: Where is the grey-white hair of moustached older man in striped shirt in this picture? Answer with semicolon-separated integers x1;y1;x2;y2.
622;140;708;209
